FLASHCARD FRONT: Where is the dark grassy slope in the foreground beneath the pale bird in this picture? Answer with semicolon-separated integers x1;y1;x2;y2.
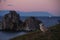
11;24;60;40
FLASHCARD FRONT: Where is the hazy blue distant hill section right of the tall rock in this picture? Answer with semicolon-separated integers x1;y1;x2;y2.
18;12;53;16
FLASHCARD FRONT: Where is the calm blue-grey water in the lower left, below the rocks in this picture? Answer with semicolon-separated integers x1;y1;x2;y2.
0;31;26;40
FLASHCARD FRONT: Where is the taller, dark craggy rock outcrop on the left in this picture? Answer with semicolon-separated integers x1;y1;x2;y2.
2;11;22;31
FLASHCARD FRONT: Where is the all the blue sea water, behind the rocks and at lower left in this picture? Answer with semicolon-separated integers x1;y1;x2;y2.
0;17;60;40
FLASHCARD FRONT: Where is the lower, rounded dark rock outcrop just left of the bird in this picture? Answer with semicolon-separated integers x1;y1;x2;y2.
23;17;42;31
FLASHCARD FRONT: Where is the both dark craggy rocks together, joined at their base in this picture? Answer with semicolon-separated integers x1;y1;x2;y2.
2;11;42;31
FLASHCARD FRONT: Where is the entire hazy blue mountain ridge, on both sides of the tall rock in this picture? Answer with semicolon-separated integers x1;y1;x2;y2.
0;10;53;16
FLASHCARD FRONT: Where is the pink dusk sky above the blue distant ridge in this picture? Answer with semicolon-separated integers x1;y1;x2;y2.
0;0;60;16
